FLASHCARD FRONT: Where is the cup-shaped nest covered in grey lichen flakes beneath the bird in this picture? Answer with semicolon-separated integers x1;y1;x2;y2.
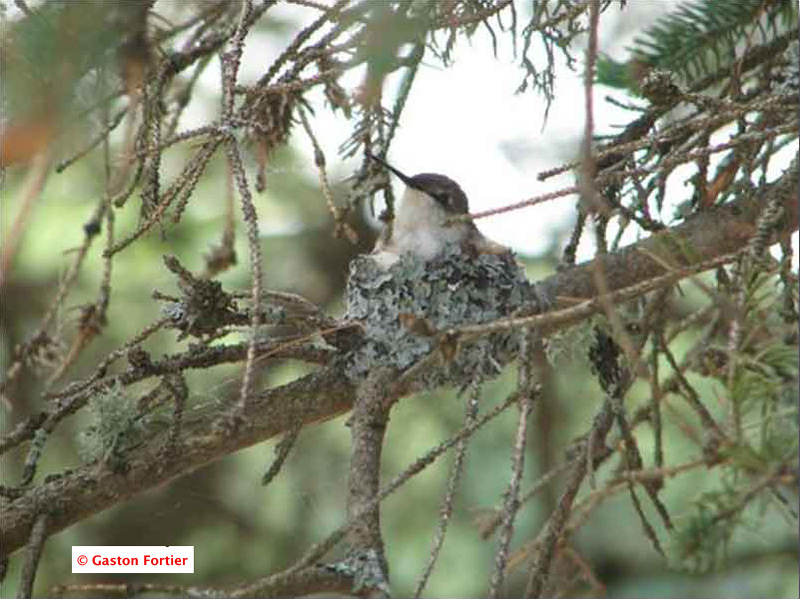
346;247;536;387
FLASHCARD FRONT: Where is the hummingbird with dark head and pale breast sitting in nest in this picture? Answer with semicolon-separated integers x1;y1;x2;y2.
367;152;511;269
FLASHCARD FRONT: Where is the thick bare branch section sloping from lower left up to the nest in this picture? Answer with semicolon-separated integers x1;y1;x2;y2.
0;368;354;556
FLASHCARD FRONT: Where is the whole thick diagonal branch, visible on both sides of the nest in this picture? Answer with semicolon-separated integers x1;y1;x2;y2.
0;157;798;560
